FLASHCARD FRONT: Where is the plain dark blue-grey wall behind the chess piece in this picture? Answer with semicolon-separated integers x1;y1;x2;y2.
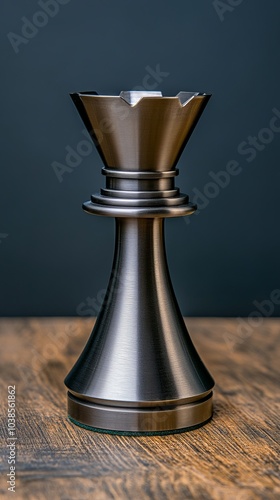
0;0;280;316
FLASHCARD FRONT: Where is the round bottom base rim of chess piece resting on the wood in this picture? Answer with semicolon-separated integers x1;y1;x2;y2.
68;392;213;435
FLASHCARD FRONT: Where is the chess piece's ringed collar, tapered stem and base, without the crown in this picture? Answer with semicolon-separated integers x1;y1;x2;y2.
65;90;214;433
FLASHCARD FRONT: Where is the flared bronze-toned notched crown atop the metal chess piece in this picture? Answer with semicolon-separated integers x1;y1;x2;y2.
72;92;210;171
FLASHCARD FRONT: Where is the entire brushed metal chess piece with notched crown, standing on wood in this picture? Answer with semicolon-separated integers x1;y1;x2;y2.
65;91;214;432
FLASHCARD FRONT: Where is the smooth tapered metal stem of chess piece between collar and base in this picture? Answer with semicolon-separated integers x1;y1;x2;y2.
65;218;214;427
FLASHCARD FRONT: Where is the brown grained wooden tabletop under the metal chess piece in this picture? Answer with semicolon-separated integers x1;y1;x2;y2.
0;318;280;500
